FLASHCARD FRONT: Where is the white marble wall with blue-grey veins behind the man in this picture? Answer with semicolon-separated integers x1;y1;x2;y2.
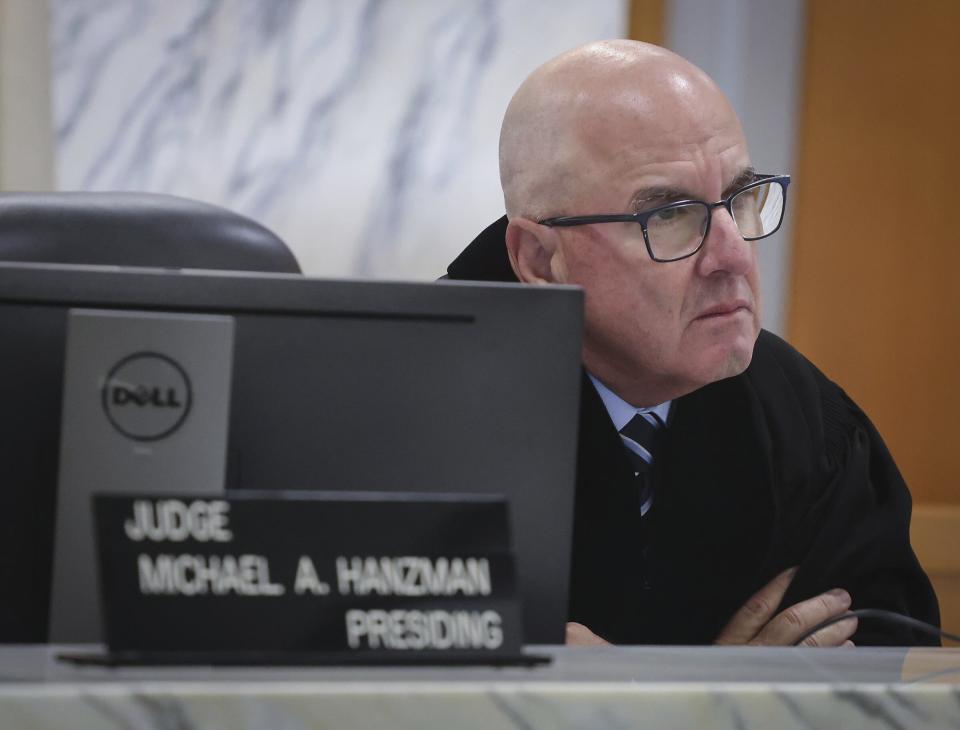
51;0;627;278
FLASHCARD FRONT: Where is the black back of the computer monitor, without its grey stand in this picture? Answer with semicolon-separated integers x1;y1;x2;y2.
0;264;582;643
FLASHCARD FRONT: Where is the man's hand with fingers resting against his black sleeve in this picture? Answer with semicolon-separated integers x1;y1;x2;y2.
712;568;857;646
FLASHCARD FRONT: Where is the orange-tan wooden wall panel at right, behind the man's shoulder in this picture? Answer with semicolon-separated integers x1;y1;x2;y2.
788;0;960;503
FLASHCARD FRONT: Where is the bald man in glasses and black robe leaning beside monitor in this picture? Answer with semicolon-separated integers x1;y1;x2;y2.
448;41;939;646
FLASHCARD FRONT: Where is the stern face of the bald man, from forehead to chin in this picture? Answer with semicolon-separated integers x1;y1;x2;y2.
551;86;760;406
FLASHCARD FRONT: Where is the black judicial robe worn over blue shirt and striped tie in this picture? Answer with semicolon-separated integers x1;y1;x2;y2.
448;218;939;645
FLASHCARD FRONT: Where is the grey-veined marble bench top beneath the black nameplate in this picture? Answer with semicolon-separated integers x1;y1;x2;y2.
0;647;960;730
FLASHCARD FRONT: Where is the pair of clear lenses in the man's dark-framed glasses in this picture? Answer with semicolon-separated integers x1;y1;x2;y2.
647;182;783;260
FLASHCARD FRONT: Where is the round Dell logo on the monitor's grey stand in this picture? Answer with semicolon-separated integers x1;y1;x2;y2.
101;352;193;441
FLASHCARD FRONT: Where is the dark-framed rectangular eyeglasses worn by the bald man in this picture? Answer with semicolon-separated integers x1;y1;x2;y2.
538;175;790;262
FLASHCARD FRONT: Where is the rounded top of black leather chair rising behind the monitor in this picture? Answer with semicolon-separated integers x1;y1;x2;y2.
0;192;300;274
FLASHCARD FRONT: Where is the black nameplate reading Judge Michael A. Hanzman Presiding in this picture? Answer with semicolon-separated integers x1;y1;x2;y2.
94;492;522;663
